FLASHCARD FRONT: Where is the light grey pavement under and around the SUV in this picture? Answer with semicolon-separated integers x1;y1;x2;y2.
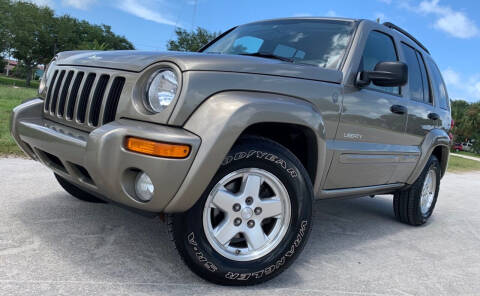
0;158;480;296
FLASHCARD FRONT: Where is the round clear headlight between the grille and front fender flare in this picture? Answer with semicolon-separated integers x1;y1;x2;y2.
145;70;178;113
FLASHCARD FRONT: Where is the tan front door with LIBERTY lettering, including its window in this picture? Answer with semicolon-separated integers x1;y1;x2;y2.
324;30;408;189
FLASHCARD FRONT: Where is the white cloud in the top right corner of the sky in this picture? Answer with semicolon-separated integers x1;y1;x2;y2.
400;0;480;39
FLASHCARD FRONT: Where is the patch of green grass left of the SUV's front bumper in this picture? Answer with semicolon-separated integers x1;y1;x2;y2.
0;84;37;155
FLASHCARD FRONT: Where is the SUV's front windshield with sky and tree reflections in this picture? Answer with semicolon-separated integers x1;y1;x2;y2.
203;19;355;69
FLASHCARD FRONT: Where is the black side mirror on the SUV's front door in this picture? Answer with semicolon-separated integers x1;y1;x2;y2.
356;62;408;87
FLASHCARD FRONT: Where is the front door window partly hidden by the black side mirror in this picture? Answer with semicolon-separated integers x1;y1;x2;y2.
360;31;400;95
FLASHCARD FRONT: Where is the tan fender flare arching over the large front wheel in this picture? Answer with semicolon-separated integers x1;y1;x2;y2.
164;91;326;213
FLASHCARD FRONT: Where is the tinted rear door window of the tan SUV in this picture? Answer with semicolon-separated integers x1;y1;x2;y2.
402;43;424;102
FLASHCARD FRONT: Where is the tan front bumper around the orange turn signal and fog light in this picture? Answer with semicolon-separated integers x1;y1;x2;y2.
11;99;201;212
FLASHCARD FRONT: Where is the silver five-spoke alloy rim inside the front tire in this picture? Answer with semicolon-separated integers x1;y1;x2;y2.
203;168;291;261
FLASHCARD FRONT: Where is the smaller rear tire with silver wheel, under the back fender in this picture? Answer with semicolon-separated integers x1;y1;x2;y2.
393;155;441;226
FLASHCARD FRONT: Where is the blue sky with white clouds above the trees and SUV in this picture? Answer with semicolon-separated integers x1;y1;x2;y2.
31;0;480;101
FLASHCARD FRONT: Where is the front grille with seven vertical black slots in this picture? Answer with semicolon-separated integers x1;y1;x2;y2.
44;67;125;129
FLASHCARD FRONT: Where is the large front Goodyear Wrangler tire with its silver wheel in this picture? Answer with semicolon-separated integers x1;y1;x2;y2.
168;137;313;285
